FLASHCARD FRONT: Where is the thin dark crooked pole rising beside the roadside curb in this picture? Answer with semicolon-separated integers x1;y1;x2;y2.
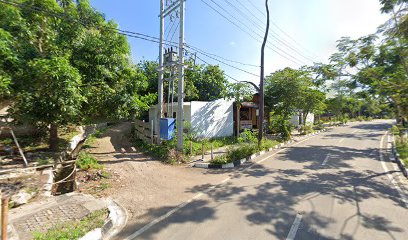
258;0;269;146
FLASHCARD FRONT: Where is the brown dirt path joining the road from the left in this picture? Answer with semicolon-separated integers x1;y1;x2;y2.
86;123;231;239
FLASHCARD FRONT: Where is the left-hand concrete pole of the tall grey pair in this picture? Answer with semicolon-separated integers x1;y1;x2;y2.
156;0;164;144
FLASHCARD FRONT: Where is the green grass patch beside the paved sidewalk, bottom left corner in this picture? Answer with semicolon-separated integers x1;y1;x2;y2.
33;209;108;240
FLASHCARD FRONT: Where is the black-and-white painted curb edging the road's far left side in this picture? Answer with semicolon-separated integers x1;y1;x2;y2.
193;128;327;169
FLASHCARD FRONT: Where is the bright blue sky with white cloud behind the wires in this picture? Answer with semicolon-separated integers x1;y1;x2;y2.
91;0;388;83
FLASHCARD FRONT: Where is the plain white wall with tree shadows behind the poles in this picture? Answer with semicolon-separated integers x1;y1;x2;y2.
191;99;234;138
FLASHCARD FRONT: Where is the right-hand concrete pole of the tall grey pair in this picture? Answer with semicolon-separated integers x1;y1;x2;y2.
177;0;184;151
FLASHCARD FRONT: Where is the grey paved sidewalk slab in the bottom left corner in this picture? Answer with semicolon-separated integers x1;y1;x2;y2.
8;193;108;240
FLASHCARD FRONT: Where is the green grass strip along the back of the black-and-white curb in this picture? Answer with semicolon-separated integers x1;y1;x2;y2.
210;139;279;165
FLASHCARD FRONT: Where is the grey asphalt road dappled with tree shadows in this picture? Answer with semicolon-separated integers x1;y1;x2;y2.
128;120;408;240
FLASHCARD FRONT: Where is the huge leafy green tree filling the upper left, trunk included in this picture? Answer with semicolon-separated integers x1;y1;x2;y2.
0;0;145;148
